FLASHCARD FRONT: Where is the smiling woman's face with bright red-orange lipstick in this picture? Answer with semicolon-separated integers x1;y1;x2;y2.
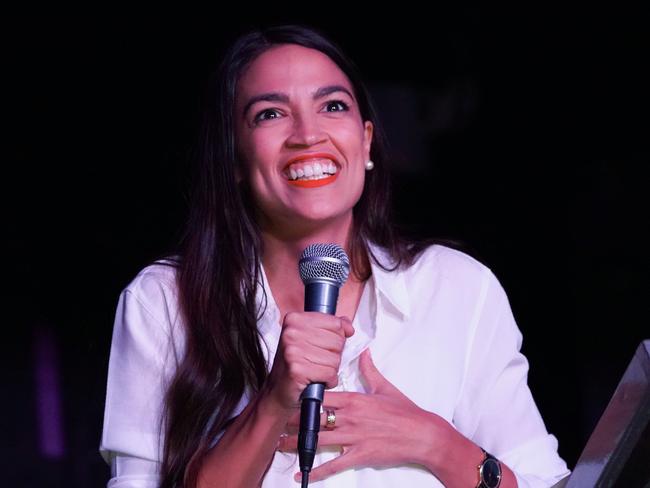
234;44;373;231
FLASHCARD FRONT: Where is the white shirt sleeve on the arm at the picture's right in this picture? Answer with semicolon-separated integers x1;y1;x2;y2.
454;270;569;488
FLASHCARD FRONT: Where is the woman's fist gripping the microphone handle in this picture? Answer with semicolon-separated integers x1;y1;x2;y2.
265;312;354;414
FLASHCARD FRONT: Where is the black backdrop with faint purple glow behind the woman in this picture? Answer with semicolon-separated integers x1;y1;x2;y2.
5;8;650;487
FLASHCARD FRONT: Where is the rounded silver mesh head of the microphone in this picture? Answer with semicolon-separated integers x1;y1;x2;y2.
298;244;350;287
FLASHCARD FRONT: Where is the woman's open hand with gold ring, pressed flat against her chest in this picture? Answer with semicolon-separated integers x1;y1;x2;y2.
279;349;453;481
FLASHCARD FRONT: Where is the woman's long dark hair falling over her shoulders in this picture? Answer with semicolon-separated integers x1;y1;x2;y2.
161;25;424;488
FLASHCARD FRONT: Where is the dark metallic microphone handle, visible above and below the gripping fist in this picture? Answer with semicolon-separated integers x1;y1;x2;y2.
298;281;339;476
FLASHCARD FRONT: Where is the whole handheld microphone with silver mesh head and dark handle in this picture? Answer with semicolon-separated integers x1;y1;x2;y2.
298;244;350;488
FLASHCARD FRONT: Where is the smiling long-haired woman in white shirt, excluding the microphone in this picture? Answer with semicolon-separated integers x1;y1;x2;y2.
101;26;568;488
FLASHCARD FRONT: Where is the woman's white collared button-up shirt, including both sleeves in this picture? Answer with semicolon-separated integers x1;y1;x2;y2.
100;245;569;488
